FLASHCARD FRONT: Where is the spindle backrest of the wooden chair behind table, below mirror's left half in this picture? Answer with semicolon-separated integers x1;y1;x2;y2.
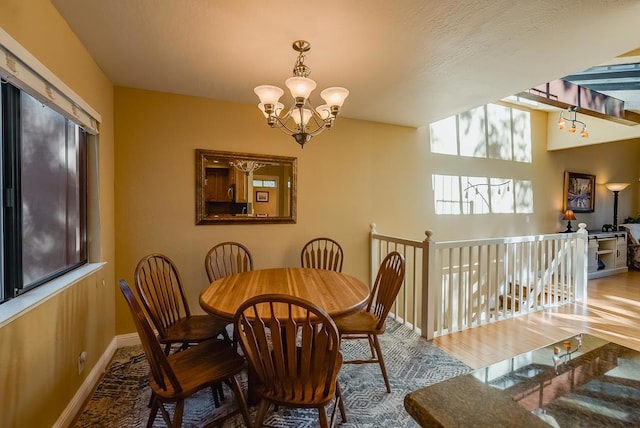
204;242;253;282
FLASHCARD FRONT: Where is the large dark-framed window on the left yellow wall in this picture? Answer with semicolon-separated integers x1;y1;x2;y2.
0;83;87;301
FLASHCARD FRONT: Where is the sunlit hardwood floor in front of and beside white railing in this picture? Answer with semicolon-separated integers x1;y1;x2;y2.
433;271;640;369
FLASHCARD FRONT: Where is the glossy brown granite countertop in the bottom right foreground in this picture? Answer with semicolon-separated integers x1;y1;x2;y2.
404;333;640;428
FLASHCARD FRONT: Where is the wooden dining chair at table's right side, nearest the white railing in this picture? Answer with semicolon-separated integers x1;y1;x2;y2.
335;251;405;392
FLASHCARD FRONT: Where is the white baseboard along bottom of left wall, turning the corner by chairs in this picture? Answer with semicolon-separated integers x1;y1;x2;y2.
53;333;140;428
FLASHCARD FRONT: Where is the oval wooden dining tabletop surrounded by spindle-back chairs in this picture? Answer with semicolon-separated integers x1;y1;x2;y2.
200;267;369;321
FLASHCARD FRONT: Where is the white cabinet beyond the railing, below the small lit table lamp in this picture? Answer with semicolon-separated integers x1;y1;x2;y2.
587;232;627;279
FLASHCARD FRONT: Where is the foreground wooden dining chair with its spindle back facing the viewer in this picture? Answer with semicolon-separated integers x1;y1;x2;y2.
234;294;346;427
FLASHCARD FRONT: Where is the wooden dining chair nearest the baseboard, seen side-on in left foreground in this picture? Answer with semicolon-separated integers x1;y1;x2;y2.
120;280;252;427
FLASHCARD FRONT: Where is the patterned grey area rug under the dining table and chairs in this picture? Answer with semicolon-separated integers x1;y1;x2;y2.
72;319;470;428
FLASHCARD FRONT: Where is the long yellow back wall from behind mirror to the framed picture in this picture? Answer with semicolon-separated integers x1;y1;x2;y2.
115;87;639;333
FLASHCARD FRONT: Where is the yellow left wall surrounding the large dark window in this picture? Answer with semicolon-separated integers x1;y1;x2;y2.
0;0;115;427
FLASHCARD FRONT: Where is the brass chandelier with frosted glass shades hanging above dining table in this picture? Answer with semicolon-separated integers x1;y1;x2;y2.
253;40;349;148
